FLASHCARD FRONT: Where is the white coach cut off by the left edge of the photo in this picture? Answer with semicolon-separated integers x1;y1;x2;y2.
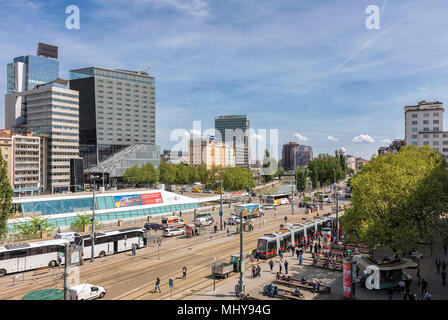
0;239;70;277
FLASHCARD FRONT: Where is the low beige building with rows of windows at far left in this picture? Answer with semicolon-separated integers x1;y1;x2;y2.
0;129;41;197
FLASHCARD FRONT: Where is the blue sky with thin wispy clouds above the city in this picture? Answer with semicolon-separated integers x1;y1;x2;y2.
0;0;448;158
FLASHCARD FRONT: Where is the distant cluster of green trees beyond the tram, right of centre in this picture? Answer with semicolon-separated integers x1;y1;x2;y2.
295;150;353;192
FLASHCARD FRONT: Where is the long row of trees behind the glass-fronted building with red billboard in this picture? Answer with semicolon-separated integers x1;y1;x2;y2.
123;162;255;191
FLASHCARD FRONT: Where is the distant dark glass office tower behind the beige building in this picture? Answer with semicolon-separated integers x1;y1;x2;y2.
215;115;250;167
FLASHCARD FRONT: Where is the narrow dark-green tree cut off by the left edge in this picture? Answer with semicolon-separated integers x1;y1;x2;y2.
0;153;13;240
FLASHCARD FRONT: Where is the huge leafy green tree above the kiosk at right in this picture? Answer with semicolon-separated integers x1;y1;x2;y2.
341;145;448;253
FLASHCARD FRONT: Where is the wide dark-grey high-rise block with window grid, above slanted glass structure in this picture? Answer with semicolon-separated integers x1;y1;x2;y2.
70;67;160;168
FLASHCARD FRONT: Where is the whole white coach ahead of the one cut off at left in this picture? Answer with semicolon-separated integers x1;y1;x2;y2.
75;228;147;259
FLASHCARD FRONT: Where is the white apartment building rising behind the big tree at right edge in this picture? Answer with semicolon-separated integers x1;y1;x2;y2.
404;101;448;158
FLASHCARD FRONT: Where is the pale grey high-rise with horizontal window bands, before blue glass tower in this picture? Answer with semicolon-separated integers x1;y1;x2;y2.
5;78;79;193
